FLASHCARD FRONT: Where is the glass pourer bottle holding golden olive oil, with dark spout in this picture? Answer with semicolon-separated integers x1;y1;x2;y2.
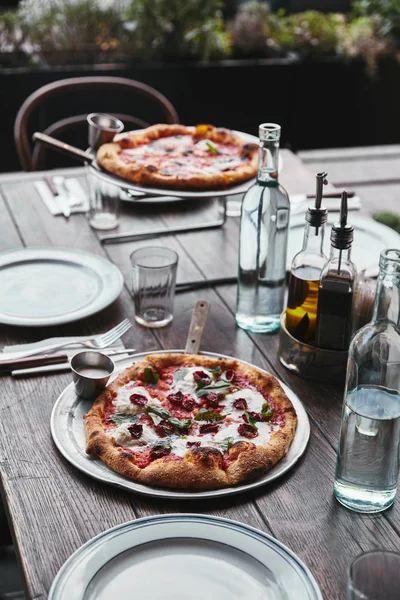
286;173;328;344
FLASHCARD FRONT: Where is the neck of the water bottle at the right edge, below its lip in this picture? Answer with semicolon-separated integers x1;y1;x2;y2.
372;269;400;327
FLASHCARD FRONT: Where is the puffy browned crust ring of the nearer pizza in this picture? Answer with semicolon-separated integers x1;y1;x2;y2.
84;353;297;490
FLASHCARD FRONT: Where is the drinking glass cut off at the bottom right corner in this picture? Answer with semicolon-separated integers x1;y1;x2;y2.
347;550;400;600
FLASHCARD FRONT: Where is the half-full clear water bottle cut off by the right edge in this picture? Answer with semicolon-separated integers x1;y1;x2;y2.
334;250;400;513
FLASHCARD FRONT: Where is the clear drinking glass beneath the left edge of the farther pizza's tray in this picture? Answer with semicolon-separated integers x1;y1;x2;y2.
87;167;121;231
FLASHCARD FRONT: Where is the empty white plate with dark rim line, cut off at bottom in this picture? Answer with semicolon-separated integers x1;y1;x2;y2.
49;514;322;600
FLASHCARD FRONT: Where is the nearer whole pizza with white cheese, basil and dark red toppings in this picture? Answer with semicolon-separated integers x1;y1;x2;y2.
84;354;297;490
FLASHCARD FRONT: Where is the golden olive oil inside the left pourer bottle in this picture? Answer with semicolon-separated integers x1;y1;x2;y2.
286;267;320;343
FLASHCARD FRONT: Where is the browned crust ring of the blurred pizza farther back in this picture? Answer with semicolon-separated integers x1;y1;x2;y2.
97;124;258;190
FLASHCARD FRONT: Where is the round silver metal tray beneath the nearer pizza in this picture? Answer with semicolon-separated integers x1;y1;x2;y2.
50;350;310;499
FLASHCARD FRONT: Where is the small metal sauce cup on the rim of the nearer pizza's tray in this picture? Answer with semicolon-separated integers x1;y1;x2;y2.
71;351;115;400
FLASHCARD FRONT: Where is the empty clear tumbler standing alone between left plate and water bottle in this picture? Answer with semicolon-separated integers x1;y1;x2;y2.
131;246;178;327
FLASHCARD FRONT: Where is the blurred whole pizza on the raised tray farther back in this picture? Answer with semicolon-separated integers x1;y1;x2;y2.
97;125;258;190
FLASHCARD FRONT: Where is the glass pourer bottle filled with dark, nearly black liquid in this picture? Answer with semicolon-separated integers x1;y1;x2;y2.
315;192;357;350
